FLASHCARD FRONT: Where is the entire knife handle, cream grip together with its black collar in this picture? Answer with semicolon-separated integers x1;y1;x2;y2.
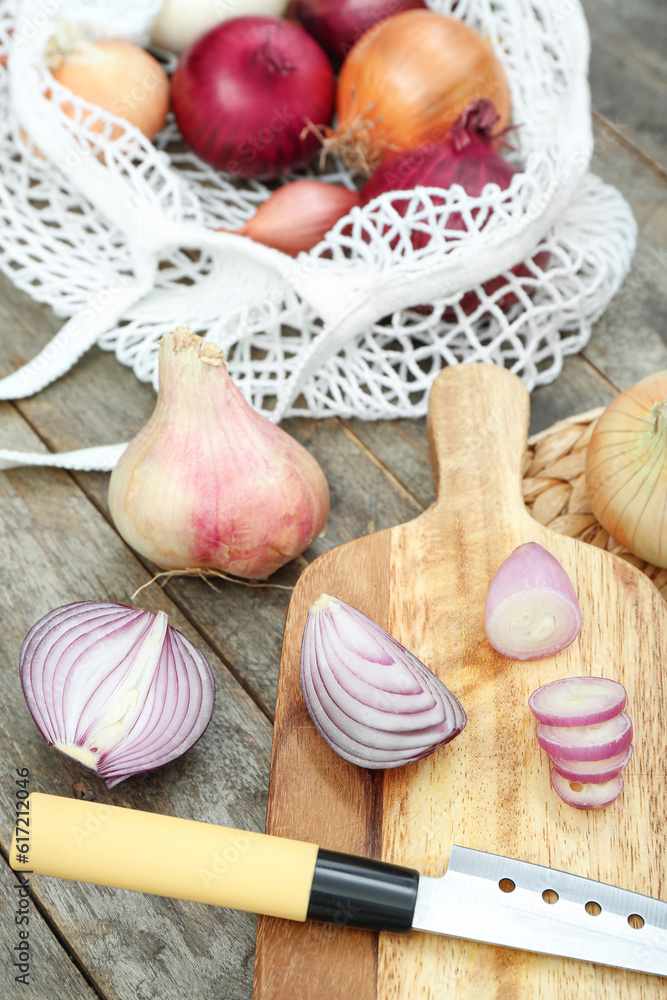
9;792;419;931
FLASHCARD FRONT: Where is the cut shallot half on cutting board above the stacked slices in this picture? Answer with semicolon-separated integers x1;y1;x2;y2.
484;542;582;660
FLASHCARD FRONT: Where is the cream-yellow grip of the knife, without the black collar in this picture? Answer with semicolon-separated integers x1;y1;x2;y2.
9;792;318;920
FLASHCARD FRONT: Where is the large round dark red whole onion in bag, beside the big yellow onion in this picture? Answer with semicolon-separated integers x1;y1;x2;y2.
171;17;334;179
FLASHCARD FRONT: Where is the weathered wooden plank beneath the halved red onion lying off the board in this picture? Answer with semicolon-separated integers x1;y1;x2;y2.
0;404;271;1000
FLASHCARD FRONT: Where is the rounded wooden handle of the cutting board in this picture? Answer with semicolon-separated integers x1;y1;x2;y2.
427;362;530;523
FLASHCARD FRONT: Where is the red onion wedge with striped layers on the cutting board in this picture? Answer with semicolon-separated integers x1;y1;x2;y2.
301;594;467;768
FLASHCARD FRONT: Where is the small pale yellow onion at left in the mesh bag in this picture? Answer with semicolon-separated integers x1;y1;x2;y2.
45;25;169;139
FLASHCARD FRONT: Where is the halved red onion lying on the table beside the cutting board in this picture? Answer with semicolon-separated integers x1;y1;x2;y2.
19;601;215;788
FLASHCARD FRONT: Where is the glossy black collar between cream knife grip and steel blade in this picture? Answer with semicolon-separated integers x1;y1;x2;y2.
307;849;419;931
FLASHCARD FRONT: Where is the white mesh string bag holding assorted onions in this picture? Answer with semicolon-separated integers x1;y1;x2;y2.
0;0;636;468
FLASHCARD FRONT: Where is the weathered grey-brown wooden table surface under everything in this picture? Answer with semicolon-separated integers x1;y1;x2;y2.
0;0;667;1000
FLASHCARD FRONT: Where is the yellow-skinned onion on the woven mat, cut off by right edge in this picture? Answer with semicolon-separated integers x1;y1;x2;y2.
586;370;667;569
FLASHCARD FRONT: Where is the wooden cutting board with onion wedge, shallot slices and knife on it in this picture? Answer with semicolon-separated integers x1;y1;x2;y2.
253;364;667;1000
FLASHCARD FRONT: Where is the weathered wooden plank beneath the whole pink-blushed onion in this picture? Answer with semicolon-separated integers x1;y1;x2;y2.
0;279;420;715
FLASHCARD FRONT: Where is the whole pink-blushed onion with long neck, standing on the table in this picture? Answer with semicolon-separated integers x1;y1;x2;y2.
109;328;329;579
